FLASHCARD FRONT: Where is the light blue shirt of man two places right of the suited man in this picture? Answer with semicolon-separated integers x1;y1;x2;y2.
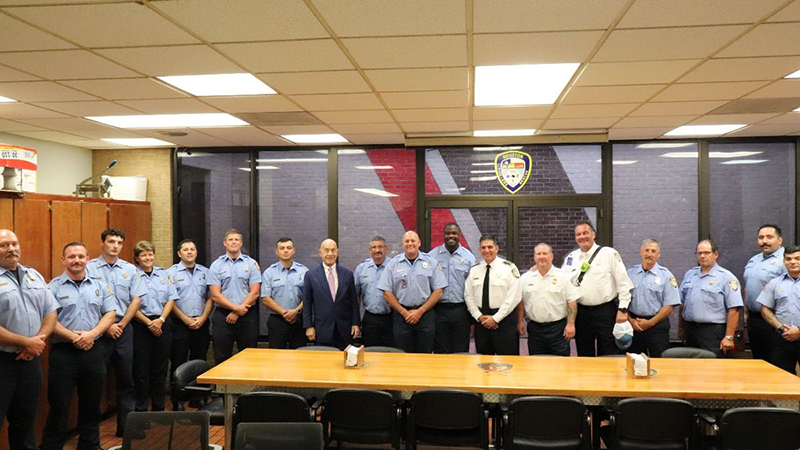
378;252;447;308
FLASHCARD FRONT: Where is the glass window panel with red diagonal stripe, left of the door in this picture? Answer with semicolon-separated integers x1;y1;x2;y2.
338;148;417;270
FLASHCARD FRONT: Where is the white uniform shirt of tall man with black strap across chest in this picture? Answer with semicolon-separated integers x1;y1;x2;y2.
561;243;633;308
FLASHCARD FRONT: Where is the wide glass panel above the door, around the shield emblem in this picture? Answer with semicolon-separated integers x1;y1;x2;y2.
425;145;602;195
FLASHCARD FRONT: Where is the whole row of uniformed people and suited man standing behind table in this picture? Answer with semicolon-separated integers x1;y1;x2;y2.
0;222;800;449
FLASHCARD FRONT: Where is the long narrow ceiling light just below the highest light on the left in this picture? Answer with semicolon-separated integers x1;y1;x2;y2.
86;113;249;128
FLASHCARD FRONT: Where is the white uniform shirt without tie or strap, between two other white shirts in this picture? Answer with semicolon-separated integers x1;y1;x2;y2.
519;266;581;323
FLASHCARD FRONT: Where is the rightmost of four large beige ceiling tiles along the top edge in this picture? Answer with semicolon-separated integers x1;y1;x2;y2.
617;0;784;28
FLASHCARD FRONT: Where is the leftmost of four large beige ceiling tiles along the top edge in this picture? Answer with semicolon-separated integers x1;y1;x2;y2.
151;0;328;42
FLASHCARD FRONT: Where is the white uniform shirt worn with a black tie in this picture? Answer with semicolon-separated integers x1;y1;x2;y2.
464;257;521;323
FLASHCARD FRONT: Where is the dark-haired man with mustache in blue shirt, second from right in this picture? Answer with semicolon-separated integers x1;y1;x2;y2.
744;223;786;361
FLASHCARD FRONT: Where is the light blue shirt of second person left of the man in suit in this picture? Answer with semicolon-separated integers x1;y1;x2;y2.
207;253;261;305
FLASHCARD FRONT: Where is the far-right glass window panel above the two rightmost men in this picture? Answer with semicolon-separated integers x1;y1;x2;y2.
708;143;795;280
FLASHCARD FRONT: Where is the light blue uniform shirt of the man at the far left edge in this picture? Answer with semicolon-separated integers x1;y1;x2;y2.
0;264;58;353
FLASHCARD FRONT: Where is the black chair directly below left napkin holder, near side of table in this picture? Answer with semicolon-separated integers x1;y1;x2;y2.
322;389;403;450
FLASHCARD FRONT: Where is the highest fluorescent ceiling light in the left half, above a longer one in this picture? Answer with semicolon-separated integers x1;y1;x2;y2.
158;73;277;97
